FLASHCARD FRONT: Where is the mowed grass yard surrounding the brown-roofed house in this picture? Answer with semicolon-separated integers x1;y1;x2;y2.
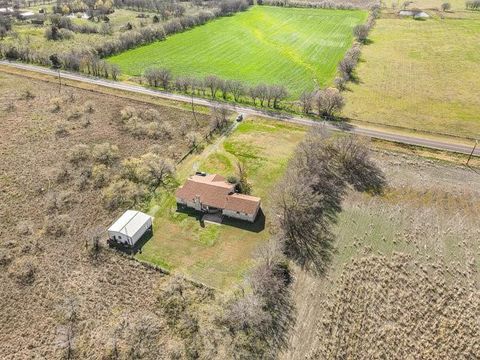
137;119;306;288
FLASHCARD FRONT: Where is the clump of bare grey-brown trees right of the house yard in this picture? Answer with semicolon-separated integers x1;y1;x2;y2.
274;128;385;274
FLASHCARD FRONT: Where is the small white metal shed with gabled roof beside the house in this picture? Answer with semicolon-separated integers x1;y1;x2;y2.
107;210;152;246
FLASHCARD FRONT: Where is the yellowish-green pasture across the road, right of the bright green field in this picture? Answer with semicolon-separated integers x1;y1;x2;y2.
344;12;480;137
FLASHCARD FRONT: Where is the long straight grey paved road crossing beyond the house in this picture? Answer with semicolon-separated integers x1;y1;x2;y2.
0;61;480;156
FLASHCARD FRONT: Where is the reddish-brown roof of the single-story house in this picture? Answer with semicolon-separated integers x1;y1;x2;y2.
175;174;260;214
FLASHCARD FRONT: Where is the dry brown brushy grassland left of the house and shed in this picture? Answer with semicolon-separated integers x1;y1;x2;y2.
0;73;216;359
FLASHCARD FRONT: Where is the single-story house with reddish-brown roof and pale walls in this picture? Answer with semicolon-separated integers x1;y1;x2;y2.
175;173;260;222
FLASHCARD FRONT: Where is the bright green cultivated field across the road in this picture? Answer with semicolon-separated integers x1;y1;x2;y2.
109;6;367;96
